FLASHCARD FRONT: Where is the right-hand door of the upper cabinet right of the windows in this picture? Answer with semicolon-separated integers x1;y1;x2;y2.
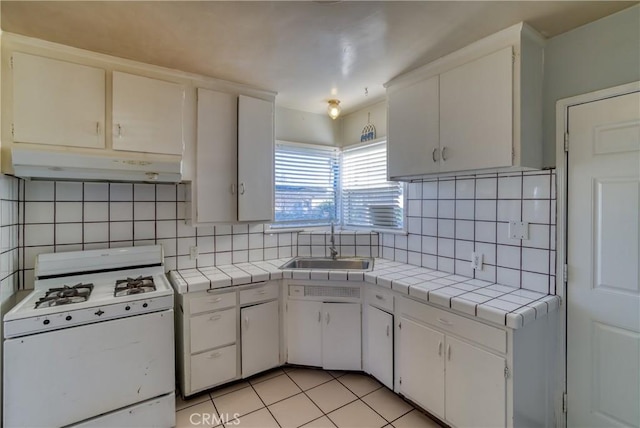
440;47;513;171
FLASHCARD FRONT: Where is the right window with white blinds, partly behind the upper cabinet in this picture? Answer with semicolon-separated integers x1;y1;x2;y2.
342;142;403;229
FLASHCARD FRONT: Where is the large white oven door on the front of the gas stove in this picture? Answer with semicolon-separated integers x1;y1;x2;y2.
3;310;175;427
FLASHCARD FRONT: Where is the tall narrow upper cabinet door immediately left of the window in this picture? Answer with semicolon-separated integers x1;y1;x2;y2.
238;95;274;221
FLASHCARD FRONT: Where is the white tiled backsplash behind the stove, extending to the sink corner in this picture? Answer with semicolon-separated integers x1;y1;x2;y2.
18;178;297;288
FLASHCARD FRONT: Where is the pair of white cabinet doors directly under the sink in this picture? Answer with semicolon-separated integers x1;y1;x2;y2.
287;300;362;370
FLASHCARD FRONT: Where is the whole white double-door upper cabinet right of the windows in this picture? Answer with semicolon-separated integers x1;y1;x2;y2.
386;23;544;180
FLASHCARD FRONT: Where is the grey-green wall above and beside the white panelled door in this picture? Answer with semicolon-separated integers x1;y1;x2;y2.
543;5;640;166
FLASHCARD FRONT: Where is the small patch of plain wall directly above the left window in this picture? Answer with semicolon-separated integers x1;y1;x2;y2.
275;107;340;146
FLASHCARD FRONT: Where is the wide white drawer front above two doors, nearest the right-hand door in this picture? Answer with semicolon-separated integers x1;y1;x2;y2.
401;299;507;354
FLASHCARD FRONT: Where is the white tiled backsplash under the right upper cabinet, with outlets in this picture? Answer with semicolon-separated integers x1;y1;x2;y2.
382;170;556;293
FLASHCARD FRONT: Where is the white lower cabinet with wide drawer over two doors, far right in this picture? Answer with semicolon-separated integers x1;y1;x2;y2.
397;301;508;428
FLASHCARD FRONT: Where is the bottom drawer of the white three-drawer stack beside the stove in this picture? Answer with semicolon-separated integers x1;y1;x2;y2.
191;345;237;391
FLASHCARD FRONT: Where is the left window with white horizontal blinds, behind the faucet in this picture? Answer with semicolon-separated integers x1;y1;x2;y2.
275;143;340;227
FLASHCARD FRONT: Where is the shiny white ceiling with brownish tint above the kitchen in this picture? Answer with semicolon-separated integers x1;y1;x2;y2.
1;0;637;113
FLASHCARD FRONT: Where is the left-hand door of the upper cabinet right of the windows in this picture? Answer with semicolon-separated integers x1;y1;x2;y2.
387;76;440;177
